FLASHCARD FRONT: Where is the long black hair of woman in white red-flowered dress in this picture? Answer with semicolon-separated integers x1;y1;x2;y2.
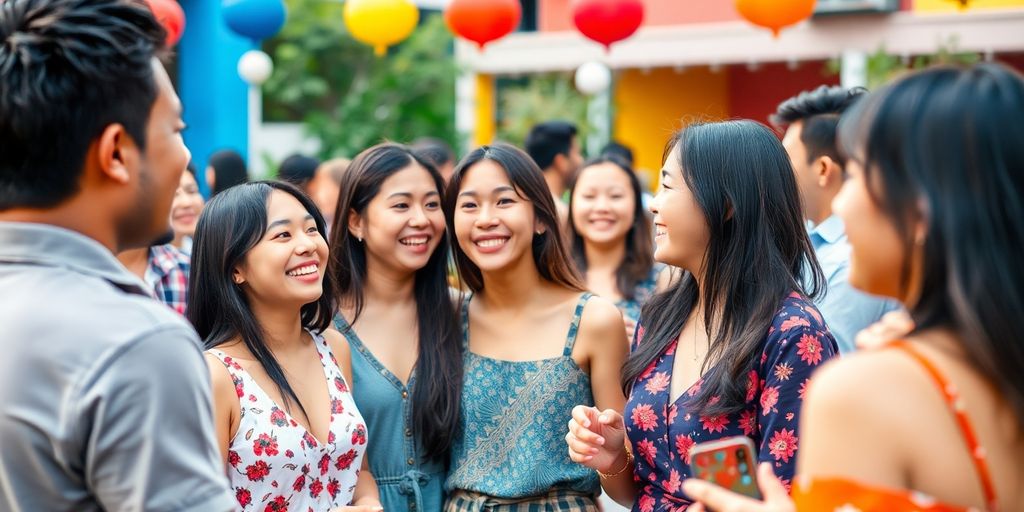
187;181;334;421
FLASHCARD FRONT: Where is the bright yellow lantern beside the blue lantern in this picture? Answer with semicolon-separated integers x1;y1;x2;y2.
343;0;420;56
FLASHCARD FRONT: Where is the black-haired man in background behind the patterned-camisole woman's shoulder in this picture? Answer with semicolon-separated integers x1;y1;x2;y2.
523;121;583;225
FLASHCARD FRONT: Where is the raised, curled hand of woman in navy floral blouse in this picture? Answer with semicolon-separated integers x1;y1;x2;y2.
565;406;627;473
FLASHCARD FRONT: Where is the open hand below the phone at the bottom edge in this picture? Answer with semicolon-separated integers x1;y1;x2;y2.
683;462;797;512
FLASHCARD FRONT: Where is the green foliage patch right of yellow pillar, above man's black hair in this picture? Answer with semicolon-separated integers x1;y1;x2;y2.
497;74;591;147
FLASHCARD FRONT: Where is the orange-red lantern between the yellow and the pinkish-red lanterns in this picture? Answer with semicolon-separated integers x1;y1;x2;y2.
444;0;522;50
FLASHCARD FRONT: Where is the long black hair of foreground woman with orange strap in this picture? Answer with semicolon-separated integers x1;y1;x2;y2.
840;63;1024;424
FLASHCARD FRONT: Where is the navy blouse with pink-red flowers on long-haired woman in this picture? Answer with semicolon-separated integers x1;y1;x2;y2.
625;294;839;512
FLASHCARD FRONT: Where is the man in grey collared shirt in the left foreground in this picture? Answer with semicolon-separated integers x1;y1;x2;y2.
0;0;238;511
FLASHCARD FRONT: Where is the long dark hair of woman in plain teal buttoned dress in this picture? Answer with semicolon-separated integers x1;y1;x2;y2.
328;143;462;465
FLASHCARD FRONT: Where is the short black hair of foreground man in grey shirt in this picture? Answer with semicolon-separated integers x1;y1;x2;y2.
0;0;166;210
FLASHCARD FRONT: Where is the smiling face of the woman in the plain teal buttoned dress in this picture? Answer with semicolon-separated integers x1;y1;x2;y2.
348;163;444;273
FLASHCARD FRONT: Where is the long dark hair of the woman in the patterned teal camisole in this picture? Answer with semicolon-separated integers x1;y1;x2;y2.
444;143;586;292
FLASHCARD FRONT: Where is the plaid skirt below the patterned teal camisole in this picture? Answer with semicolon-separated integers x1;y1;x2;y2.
444;488;601;512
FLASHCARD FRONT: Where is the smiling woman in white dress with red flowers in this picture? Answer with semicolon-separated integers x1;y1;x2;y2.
188;181;379;511
